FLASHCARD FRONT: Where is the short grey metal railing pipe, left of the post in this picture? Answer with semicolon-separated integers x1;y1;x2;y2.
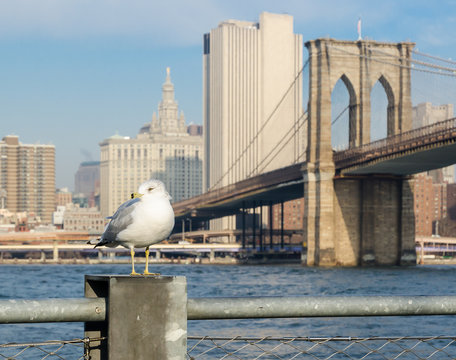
0;298;106;324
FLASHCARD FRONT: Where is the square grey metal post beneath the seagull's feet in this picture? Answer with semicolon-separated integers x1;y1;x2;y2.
85;275;187;360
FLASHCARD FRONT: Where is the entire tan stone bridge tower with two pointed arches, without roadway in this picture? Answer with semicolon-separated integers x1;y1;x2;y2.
303;39;416;266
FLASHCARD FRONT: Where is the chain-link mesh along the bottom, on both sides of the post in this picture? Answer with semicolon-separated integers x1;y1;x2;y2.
0;336;456;360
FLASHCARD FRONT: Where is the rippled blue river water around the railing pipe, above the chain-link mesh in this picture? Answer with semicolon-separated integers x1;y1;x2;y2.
0;264;456;352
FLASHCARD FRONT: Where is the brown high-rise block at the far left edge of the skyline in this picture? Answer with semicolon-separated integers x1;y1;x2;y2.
0;135;55;223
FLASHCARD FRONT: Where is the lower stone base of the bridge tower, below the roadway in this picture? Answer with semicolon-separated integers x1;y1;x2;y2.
303;176;416;266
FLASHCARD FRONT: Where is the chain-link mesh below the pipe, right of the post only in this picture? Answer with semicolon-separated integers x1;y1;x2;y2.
187;336;456;360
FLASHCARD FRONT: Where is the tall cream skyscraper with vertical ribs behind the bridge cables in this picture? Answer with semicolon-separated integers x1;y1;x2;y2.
203;12;305;228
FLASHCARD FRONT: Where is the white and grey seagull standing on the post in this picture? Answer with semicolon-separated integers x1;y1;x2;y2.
91;179;174;275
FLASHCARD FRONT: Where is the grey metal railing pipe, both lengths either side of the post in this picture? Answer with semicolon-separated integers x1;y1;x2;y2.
4;296;456;324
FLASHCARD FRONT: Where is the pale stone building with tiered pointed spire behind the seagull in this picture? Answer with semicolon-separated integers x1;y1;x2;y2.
100;68;203;216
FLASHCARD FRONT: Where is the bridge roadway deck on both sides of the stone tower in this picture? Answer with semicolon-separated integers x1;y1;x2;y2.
173;118;456;226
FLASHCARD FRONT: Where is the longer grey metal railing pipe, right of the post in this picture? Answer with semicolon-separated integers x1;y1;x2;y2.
187;296;456;320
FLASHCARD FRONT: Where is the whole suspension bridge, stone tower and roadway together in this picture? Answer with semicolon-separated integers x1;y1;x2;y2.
173;39;456;266
